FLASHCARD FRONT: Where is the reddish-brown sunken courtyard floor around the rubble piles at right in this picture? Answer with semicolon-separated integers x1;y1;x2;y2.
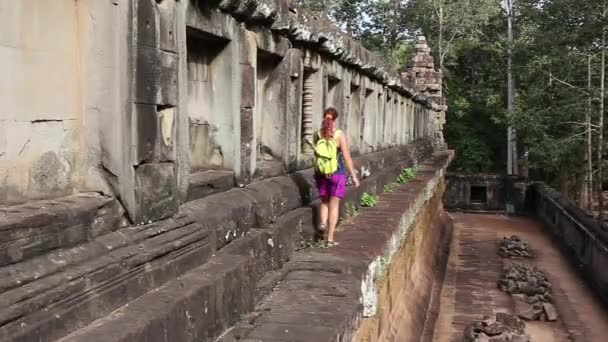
426;213;608;342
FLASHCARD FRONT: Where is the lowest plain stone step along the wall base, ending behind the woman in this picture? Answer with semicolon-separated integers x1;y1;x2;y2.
60;208;312;342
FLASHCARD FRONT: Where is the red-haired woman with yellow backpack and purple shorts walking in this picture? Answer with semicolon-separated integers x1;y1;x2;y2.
314;107;359;246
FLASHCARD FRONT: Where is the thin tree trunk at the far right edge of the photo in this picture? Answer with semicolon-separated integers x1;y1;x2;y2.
597;24;606;223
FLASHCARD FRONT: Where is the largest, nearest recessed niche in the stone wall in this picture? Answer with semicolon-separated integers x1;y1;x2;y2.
186;27;236;201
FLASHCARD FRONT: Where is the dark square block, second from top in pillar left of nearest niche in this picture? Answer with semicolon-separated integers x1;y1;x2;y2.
135;45;178;106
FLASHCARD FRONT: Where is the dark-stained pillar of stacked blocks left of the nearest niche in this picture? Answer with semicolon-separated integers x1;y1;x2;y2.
102;0;182;223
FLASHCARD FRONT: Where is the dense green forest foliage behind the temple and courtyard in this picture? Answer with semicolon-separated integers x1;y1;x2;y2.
299;0;608;196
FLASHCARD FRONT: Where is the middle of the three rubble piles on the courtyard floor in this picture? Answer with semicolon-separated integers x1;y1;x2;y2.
498;262;557;321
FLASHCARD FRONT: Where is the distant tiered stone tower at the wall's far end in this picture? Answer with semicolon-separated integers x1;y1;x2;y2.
403;36;447;149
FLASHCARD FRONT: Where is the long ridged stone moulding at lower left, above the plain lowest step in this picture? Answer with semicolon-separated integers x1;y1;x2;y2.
0;218;215;341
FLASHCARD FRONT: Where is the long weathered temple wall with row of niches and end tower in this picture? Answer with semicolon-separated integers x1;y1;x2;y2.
0;0;445;223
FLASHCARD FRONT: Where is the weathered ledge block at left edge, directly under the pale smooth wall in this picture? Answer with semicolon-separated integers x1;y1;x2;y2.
0;193;128;267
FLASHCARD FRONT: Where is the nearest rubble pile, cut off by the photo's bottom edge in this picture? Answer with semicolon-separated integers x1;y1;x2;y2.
464;312;530;342
